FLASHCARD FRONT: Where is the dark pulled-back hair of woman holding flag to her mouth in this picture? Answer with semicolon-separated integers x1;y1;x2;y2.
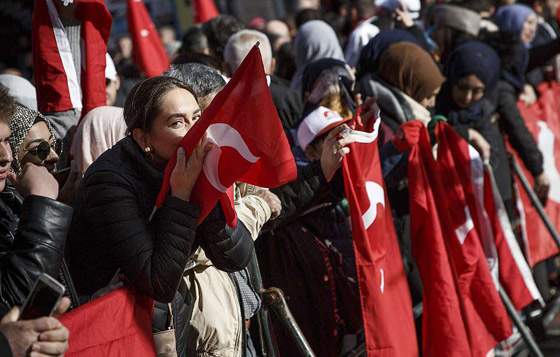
123;76;198;134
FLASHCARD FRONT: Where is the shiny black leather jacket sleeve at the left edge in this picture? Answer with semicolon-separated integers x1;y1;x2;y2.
0;188;72;315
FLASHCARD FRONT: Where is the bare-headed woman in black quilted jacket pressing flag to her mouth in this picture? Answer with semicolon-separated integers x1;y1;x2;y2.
67;77;253;356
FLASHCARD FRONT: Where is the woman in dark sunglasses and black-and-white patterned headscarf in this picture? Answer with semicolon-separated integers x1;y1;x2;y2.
8;104;83;204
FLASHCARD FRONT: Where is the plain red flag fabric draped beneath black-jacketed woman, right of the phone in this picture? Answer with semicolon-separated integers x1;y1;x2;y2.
60;287;155;357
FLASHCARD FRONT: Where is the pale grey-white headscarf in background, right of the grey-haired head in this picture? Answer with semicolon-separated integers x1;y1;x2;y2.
291;20;344;93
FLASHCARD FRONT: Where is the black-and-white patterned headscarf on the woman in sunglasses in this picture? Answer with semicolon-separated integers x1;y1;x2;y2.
8;105;55;176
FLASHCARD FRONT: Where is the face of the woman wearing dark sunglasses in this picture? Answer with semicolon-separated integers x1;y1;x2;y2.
18;121;60;172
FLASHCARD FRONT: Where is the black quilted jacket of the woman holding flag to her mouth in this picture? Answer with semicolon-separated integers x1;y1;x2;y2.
67;137;253;356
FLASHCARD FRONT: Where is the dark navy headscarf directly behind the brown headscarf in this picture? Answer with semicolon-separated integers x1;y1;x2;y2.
357;29;422;78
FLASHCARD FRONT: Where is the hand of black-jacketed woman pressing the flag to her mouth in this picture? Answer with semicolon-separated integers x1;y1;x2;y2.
169;134;213;202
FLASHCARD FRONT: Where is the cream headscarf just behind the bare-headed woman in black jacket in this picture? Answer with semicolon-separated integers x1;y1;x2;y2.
70;107;126;172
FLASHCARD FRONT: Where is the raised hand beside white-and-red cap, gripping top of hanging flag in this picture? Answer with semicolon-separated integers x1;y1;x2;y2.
321;124;354;182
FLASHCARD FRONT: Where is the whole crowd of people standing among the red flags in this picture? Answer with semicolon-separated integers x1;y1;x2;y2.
0;0;560;356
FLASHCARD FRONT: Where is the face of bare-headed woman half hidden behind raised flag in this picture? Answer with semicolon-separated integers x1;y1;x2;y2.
145;88;201;165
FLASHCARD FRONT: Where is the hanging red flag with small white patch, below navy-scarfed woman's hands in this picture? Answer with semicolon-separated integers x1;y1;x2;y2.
433;122;512;356
